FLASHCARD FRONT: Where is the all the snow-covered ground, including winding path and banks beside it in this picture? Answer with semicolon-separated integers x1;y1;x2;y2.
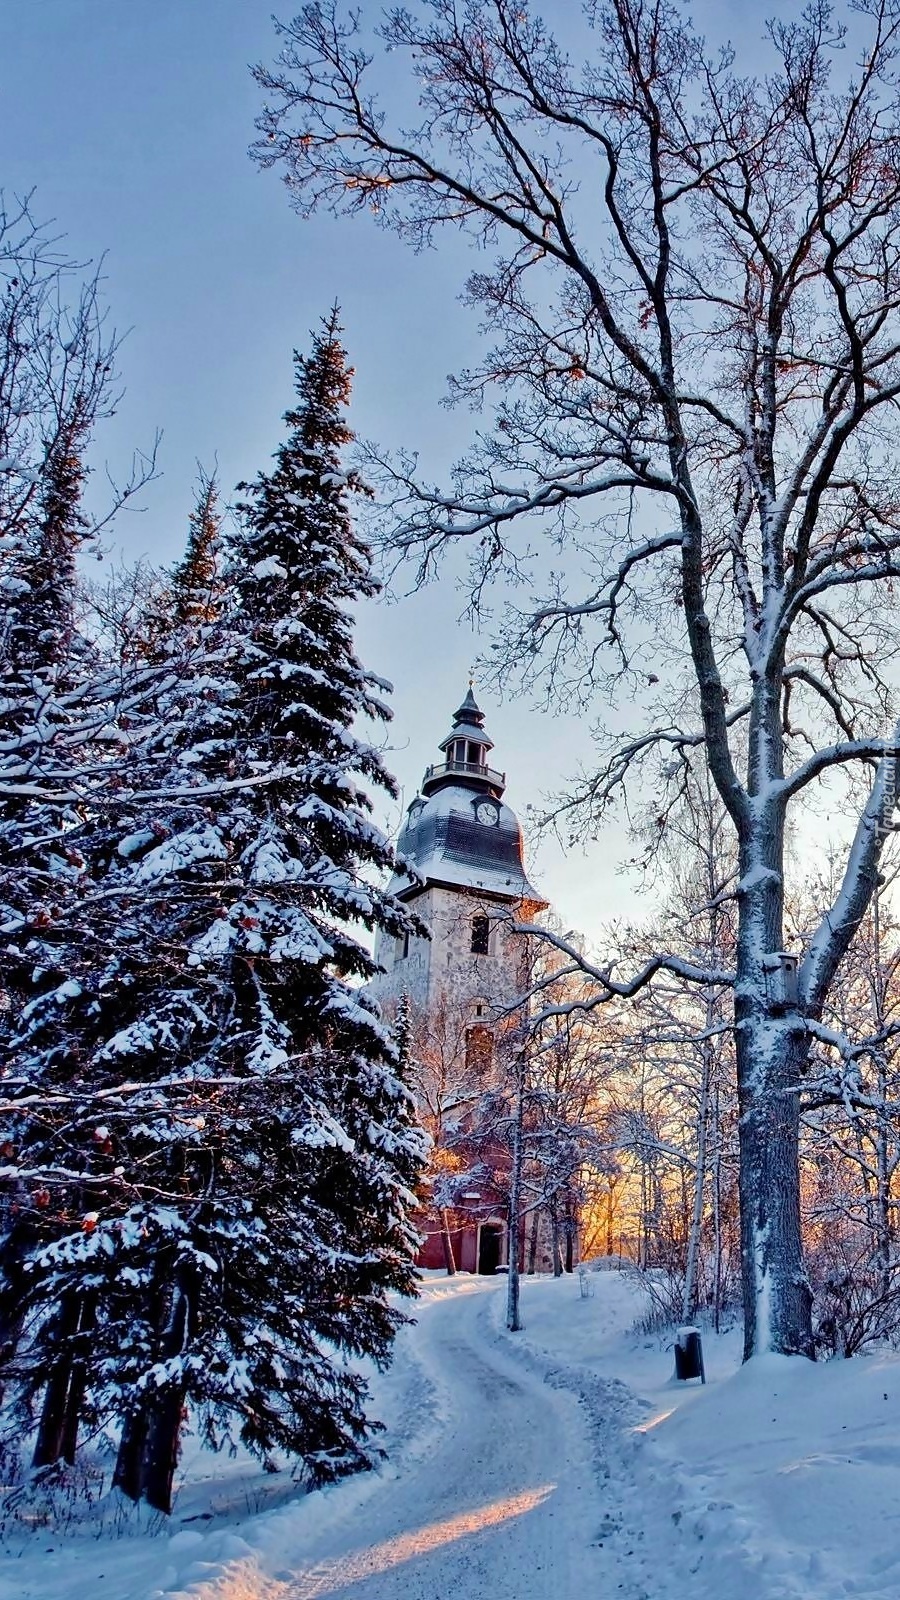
0;1272;900;1600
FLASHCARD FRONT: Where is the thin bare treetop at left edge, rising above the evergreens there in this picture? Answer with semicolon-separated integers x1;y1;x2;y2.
0;192;157;806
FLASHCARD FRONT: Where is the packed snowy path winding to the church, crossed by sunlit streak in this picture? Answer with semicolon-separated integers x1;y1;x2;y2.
235;1280;602;1600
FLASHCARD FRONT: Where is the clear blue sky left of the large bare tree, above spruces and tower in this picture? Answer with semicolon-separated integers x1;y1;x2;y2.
0;0;756;933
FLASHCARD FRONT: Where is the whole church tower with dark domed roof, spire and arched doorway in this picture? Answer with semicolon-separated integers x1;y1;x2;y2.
370;685;548;1274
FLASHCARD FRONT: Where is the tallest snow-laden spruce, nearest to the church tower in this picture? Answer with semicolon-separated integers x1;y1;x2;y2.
10;315;423;1510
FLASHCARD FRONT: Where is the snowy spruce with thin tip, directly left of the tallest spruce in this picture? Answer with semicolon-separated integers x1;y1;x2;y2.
8;474;232;1466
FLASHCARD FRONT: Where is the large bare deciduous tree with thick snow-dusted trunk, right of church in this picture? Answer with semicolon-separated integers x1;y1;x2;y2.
258;0;900;1354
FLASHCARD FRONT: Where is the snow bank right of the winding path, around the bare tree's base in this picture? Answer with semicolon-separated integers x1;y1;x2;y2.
495;1272;900;1600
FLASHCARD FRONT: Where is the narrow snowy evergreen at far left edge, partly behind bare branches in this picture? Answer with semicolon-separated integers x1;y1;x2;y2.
0;409;99;1440
